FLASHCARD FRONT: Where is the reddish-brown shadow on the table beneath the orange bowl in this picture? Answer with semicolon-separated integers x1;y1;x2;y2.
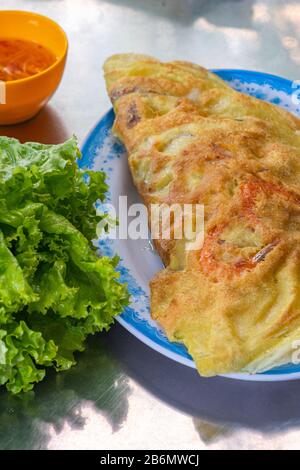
0;105;71;144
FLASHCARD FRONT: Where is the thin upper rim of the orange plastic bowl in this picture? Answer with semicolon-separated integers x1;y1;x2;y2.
0;10;69;87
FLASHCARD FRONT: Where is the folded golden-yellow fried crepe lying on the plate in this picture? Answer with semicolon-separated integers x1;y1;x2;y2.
104;54;300;376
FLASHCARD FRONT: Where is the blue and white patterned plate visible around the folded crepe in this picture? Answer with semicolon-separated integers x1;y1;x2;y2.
79;69;300;381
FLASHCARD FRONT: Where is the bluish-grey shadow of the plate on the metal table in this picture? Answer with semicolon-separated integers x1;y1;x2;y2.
108;325;300;432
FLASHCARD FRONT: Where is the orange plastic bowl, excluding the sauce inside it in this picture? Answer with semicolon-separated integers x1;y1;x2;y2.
0;10;68;124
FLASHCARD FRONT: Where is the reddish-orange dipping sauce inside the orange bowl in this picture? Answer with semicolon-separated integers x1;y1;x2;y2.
0;38;56;82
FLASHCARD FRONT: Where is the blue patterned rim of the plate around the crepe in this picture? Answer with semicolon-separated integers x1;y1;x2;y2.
78;69;300;381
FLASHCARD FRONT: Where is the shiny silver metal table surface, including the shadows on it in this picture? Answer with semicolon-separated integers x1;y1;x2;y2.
0;0;300;449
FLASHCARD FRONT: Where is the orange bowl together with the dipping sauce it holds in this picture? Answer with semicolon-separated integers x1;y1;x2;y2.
0;9;68;125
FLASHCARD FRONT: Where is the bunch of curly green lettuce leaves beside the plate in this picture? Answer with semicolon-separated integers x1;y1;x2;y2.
0;137;128;394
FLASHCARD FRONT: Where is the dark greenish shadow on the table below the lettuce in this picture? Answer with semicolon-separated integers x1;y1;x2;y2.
0;335;130;450
